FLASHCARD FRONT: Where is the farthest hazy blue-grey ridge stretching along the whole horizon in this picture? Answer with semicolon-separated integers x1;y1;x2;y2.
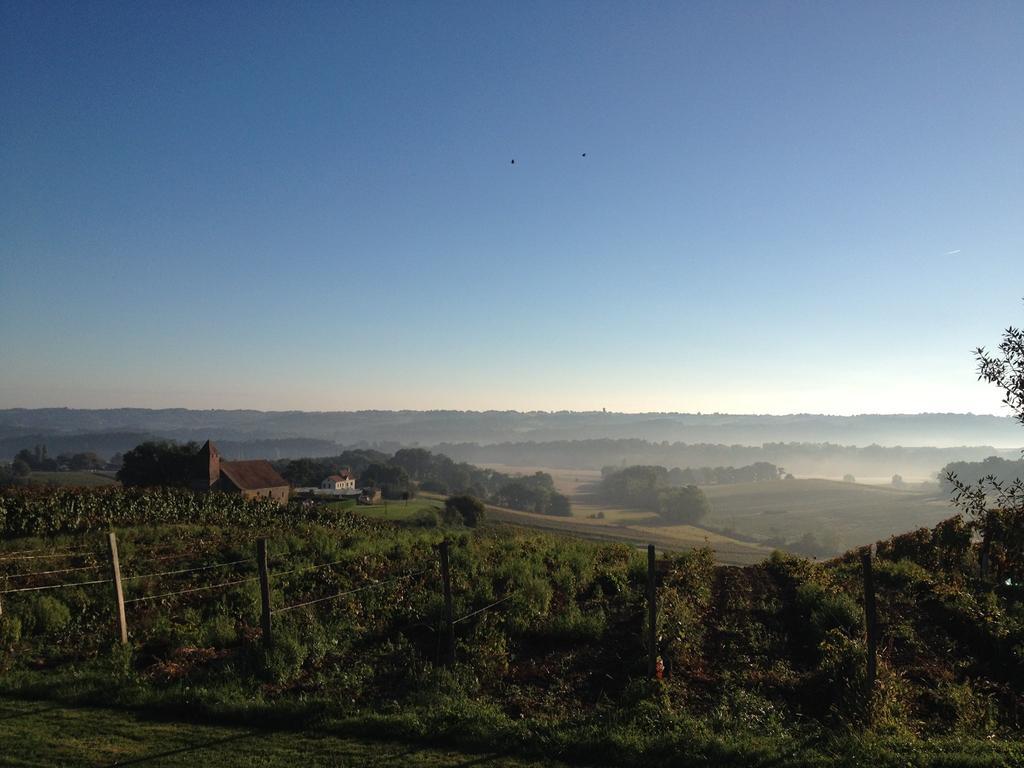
0;408;1024;450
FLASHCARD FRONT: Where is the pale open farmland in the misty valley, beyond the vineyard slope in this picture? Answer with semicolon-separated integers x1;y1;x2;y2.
475;464;954;563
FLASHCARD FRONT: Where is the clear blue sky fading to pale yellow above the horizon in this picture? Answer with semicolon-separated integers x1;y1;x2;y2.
0;0;1024;414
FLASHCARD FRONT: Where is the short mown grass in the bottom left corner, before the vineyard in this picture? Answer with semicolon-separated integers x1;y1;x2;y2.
0;698;556;768
